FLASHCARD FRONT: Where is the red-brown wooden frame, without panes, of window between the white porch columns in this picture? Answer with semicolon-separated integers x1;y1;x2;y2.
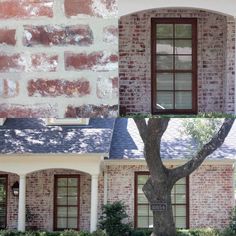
53;174;80;231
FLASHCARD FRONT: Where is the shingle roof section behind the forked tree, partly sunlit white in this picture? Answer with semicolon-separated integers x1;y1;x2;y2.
110;118;236;160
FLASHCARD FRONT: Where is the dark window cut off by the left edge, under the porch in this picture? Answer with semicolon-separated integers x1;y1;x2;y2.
0;175;7;229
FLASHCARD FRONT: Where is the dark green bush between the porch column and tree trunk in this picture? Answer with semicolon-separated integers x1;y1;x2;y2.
99;201;131;236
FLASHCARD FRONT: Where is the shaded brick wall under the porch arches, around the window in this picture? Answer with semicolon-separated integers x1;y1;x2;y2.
0;169;91;231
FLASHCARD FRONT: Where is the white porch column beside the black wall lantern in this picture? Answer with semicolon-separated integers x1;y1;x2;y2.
17;175;26;232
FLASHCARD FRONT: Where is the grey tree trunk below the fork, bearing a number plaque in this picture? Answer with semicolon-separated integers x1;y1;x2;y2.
143;178;176;236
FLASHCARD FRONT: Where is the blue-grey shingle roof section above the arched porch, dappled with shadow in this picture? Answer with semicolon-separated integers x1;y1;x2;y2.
0;118;115;154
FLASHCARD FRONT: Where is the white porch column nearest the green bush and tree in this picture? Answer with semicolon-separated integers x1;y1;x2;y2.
90;175;98;232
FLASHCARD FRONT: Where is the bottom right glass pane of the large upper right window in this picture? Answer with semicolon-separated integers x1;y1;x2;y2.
175;92;192;109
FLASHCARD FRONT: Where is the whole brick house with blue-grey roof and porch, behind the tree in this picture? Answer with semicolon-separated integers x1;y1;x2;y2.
0;118;236;231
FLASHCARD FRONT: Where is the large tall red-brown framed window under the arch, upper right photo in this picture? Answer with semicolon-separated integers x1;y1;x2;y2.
151;18;197;114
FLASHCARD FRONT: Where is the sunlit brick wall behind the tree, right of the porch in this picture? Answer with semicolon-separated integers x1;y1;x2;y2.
103;165;234;228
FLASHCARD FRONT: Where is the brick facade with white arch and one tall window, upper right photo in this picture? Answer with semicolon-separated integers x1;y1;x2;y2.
118;0;236;114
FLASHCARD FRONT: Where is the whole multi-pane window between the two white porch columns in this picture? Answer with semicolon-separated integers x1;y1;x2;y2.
54;175;80;230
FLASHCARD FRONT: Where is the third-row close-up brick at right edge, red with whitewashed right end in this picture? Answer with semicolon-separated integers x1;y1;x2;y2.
65;51;118;71
